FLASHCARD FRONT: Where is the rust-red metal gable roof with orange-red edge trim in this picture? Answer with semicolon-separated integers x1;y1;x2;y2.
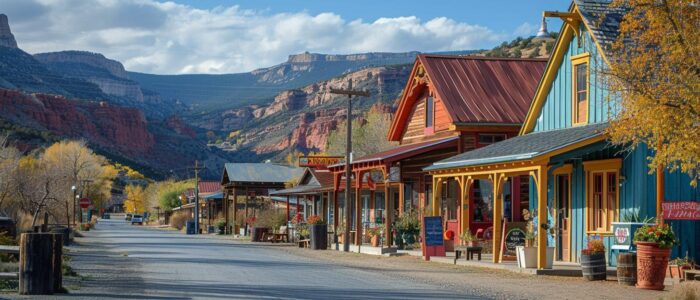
389;54;546;141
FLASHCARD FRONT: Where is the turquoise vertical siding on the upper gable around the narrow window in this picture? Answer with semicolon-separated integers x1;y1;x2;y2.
534;25;609;132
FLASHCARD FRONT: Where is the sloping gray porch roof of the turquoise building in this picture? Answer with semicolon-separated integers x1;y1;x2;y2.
424;123;608;171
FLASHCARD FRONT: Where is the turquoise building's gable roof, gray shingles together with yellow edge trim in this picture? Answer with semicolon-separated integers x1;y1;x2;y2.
520;0;625;135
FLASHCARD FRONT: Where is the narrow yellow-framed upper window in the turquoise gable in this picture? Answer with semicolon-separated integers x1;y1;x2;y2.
571;53;590;125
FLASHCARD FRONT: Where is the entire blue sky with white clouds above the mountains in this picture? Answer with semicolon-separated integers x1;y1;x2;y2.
0;0;570;74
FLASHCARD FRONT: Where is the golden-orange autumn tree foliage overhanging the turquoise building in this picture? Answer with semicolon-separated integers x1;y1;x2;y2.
603;0;700;185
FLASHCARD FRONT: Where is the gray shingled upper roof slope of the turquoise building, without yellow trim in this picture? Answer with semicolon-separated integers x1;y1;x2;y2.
574;0;626;57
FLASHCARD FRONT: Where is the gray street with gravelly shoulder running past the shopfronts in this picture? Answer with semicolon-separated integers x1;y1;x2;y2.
2;220;668;300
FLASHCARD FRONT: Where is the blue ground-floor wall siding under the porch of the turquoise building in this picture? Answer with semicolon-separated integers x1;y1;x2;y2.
530;142;700;266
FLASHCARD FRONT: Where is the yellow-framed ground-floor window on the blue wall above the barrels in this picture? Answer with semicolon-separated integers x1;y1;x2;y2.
583;159;621;234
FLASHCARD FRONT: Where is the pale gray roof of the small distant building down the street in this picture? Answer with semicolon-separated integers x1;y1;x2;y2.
223;163;304;184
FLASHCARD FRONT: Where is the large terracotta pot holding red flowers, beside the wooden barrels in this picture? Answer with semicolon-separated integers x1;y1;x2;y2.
636;242;671;290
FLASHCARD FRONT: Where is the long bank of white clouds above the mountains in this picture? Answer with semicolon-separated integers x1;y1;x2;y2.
2;0;508;74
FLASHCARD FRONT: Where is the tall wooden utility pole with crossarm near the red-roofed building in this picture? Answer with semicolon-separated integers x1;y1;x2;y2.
331;79;369;252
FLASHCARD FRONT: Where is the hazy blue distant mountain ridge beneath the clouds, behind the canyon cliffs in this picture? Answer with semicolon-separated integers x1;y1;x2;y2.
129;51;482;112
